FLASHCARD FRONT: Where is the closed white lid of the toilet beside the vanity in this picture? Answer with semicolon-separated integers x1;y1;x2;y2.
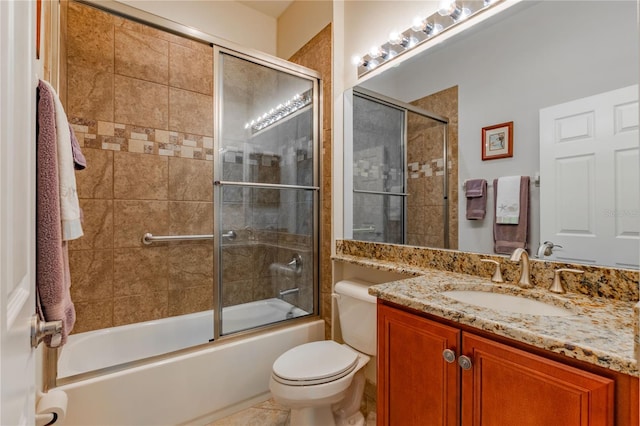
273;340;358;385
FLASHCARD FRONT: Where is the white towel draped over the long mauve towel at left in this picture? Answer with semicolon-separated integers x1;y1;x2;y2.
43;81;83;241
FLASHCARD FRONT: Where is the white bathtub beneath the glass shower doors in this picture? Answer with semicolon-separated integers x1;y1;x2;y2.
57;299;324;426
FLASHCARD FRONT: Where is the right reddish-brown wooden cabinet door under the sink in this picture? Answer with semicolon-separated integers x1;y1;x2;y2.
462;333;614;426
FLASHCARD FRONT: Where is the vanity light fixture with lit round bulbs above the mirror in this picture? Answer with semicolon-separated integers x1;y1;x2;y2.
353;0;506;77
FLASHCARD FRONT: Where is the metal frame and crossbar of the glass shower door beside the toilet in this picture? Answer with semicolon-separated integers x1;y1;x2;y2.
212;45;323;341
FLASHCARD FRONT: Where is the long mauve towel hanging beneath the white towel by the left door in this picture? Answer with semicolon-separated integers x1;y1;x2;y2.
36;81;76;347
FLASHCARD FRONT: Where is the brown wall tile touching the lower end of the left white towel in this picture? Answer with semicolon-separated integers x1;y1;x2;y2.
69;198;113;250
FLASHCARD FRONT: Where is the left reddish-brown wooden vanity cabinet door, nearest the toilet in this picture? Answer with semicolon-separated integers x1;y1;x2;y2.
377;304;461;426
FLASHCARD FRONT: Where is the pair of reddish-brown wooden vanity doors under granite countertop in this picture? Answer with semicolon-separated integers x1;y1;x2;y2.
377;303;614;426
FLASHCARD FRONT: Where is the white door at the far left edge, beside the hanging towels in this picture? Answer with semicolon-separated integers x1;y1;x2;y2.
0;0;37;426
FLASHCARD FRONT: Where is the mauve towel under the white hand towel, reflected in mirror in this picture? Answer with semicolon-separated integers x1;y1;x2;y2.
493;176;529;254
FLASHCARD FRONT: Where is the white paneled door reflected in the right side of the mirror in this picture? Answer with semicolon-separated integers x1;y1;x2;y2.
540;85;640;268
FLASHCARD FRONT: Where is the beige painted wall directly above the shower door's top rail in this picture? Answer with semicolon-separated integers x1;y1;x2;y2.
117;0;277;55
